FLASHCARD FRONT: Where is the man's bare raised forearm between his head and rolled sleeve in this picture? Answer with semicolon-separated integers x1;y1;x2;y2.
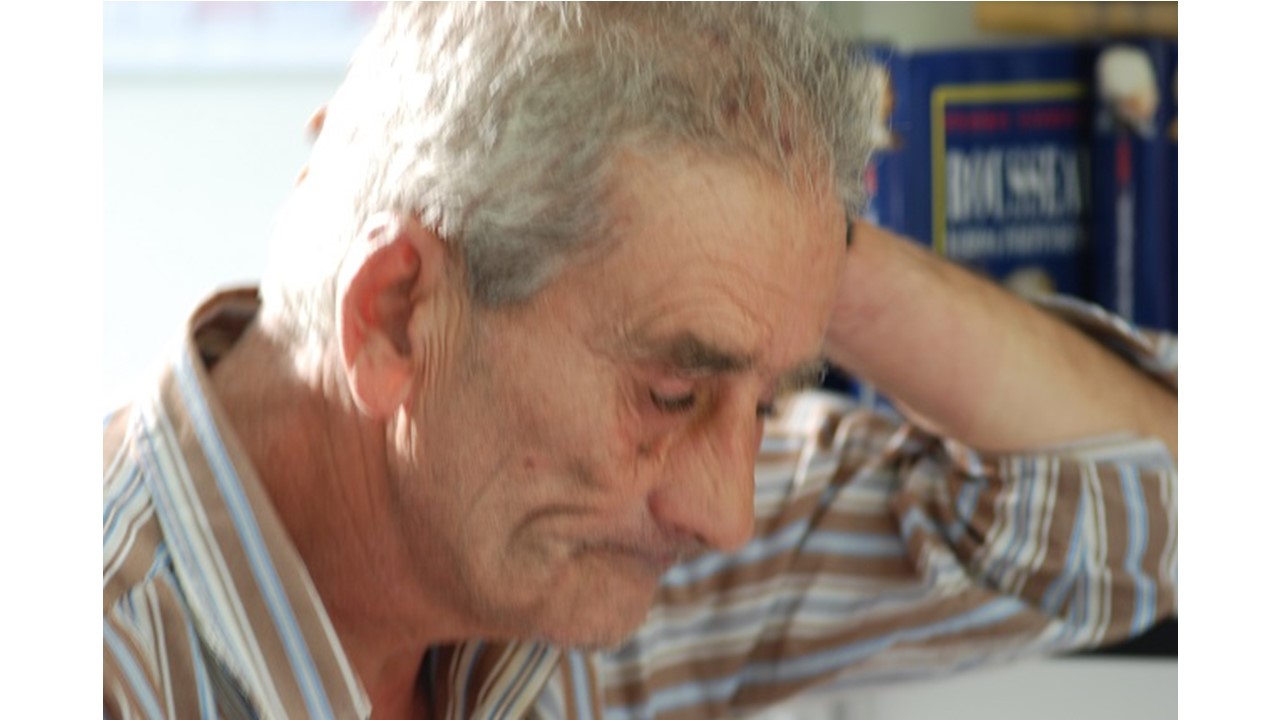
827;222;1178;460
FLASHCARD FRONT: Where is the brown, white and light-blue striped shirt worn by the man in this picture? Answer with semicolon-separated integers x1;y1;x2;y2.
102;290;1178;719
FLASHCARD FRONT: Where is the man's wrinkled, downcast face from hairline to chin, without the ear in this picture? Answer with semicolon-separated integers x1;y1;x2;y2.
398;147;845;646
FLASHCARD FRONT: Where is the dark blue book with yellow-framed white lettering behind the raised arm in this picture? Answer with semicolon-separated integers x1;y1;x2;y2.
905;44;1091;297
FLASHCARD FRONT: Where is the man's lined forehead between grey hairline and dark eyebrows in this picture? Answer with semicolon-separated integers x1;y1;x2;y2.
560;146;849;379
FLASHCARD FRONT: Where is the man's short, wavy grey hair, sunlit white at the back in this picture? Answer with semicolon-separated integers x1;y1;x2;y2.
264;3;878;351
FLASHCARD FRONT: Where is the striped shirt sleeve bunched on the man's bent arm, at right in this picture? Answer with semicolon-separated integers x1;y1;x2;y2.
593;301;1178;717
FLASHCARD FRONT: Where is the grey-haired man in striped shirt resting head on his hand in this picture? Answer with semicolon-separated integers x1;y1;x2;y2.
102;4;1176;717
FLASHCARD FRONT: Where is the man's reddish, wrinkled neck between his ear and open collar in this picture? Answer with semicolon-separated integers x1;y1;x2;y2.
211;324;468;717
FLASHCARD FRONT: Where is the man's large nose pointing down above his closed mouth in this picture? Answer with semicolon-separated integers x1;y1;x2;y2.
649;404;762;552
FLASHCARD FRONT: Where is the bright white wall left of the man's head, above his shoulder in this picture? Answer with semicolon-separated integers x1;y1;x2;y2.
102;73;340;404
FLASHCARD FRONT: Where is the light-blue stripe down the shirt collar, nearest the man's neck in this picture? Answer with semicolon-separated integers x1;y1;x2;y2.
175;354;333;717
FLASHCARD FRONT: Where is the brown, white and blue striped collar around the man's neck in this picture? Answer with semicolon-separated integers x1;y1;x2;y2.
141;288;559;717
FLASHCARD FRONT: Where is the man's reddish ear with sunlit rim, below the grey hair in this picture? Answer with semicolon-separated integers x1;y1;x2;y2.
337;214;447;419
